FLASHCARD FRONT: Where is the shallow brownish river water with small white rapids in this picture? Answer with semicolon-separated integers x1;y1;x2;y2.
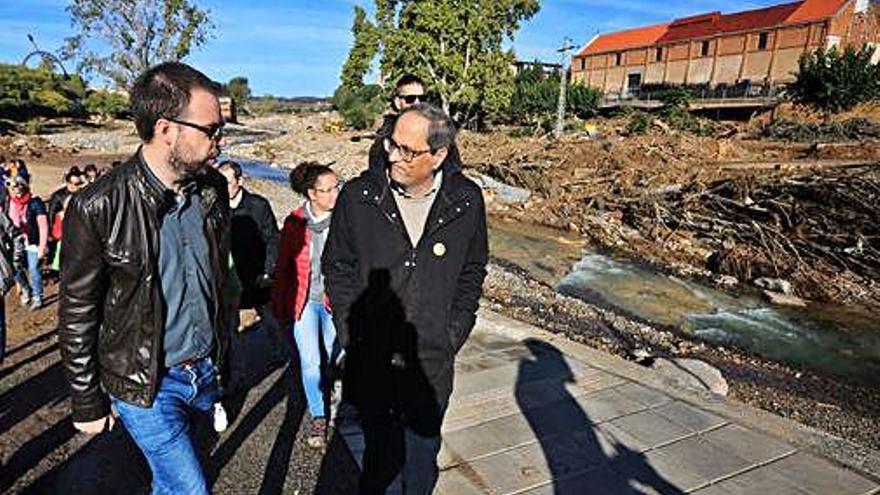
237;159;880;387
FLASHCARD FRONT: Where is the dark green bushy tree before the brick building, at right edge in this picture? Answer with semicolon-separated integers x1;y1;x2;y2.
786;45;880;112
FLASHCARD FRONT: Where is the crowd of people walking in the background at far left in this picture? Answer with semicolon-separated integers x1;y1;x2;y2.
0;156;104;362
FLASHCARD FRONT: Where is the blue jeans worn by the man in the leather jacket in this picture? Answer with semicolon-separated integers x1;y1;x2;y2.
111;358;220;495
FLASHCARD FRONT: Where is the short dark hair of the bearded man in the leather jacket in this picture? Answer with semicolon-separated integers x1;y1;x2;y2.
131;62;220;143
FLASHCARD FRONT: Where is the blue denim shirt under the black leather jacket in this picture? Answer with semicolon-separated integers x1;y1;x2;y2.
147;167;214;367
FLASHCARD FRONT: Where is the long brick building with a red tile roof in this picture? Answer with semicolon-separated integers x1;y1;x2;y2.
572;0;880;98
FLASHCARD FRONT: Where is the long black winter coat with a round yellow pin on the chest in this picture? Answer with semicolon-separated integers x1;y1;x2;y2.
322;148;488;427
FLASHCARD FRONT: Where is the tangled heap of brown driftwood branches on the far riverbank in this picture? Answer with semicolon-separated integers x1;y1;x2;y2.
623;164;880;304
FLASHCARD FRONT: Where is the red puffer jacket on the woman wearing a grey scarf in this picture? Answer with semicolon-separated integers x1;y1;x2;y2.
272;206;329;325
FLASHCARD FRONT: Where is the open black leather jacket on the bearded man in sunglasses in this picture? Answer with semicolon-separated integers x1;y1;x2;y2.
58;152;230;422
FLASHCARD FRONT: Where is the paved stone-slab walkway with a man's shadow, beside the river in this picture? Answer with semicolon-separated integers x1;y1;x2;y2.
339;312;880;495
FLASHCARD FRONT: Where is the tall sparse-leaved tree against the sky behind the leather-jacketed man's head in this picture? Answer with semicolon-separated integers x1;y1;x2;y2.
62;0;213;88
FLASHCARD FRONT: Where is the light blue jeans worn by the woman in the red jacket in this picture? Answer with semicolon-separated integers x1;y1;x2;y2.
292;301;336;418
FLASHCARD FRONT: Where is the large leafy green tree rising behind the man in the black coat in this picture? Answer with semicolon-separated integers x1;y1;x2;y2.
343;0;540;123
